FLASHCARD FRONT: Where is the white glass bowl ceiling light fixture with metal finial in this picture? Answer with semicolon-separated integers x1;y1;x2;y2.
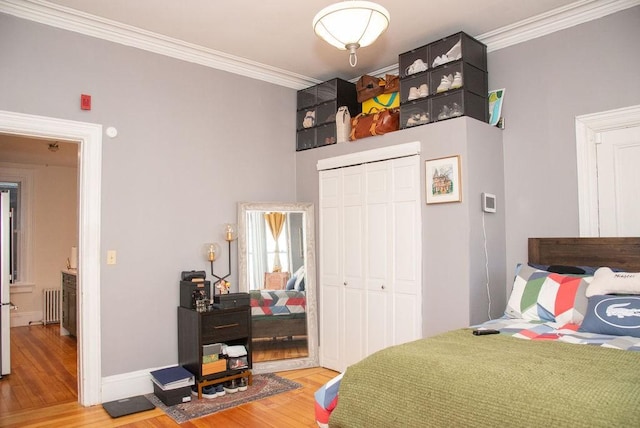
313;0;390;67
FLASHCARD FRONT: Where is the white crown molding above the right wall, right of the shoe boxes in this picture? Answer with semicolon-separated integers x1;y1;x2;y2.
476;0;640;52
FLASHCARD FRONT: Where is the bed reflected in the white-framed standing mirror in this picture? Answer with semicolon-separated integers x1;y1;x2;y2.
249;289;307;339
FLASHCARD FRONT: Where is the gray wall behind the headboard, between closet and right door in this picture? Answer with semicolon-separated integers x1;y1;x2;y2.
488;7;640;278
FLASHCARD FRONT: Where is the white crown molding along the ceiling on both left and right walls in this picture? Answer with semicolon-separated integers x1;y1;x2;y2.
0;0;640;90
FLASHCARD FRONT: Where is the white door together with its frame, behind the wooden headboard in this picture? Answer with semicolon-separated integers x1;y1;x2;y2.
576;105;640;237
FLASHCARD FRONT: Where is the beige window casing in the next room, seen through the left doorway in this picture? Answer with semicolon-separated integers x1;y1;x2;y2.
0;167;33;285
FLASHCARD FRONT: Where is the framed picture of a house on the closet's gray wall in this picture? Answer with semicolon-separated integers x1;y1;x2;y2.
425;155;462;204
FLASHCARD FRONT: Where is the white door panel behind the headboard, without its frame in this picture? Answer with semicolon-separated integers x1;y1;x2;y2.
596;126;640;236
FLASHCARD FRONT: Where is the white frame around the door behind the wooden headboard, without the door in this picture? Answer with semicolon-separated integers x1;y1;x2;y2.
576;105;640;237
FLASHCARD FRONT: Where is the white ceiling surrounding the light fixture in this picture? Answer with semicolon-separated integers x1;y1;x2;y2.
21;0;584;82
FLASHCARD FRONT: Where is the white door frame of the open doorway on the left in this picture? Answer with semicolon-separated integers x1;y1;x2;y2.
0;110;102;406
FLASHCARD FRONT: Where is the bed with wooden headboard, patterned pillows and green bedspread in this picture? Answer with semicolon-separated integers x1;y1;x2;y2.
315;238;640;427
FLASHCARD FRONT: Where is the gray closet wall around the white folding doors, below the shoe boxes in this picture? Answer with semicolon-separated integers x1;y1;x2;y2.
296;117;506;336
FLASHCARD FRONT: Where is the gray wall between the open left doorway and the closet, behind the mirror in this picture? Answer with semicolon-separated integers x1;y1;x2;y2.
0;14;296;376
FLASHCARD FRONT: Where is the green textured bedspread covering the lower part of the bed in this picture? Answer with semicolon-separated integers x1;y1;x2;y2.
329;329;640;428
